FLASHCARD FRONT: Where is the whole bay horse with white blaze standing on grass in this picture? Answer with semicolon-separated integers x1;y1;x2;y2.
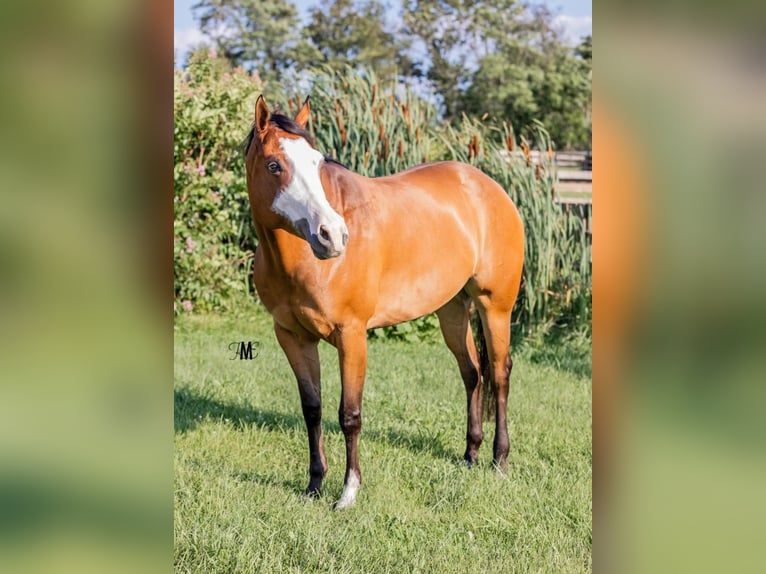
244;96;524;509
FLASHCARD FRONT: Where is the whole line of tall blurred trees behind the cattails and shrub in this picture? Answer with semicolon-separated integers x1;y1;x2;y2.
189;0;592;149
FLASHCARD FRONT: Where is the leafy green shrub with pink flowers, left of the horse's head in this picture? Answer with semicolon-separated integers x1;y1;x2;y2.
173;51;260;313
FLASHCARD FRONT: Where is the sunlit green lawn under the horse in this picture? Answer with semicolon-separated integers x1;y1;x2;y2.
174;304;592;574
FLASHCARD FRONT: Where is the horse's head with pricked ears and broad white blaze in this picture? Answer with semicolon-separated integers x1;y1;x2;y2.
245;96;348;259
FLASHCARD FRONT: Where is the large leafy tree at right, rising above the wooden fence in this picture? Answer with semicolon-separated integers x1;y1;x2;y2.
404;0;591;148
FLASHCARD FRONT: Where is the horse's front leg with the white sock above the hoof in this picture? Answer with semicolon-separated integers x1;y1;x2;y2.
336;327;367;509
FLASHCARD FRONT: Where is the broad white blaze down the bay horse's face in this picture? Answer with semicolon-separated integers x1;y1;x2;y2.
271;138;348;254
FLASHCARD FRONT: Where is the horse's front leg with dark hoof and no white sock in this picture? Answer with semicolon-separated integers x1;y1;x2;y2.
274;323;327;496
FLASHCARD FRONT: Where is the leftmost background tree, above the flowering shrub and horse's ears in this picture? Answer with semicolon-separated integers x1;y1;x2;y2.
193;0;309;81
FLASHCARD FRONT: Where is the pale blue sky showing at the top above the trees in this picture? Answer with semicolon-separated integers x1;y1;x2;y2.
173;0;593;66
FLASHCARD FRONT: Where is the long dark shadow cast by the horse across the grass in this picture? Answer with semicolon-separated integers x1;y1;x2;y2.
173;389;462;463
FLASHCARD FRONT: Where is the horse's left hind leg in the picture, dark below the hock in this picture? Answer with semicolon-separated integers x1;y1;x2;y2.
436;291;483;464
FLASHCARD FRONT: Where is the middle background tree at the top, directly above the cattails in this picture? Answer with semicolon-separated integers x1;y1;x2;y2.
304;0;411;78
